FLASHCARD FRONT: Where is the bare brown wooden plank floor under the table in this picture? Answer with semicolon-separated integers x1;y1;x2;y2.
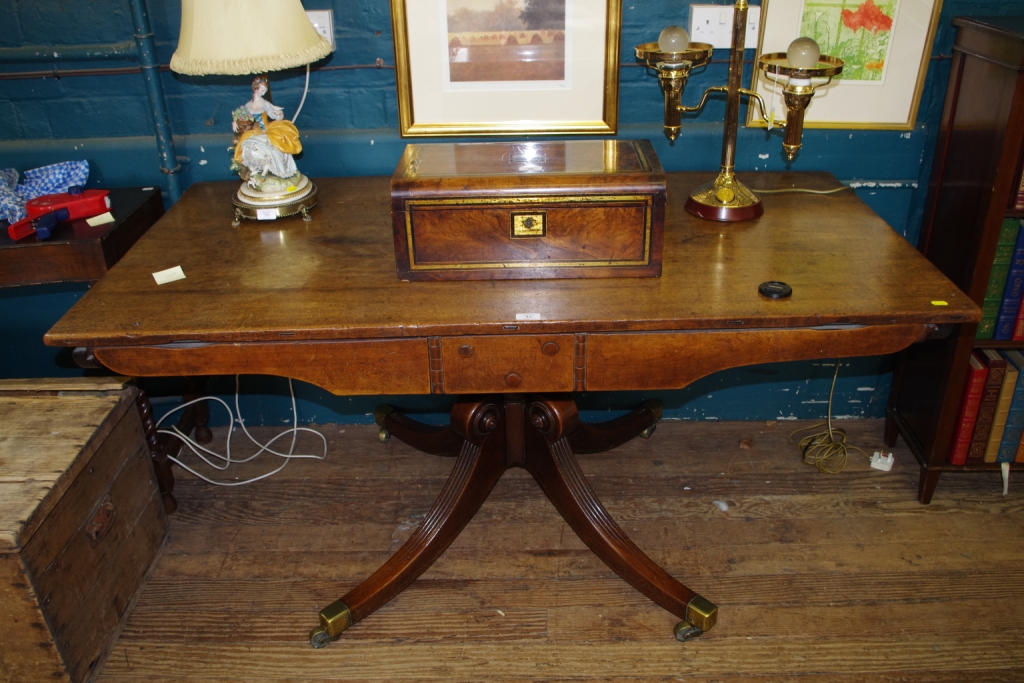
98;421;1024;683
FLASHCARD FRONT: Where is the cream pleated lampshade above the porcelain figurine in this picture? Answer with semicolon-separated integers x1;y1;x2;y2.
171;0;331;76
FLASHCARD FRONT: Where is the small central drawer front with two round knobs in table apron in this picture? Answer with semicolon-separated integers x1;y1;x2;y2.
441;335;574;393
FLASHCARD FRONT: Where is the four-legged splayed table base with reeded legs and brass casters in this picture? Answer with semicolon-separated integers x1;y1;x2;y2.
309;394;718;648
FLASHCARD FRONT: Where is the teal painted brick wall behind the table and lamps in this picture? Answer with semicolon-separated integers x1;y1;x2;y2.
0;0;1024;424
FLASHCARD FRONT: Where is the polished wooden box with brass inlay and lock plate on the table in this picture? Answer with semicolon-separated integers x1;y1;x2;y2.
391;140;666;281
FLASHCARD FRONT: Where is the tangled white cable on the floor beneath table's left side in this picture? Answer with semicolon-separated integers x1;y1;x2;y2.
157;375;327;486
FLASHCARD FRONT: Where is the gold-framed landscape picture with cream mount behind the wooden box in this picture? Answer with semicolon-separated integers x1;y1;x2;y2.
391;0;622;137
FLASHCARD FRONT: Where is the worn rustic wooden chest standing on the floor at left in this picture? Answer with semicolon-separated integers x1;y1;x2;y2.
0;378;167;683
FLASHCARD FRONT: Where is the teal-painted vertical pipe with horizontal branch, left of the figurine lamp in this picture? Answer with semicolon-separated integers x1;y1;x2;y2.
0;0;181;204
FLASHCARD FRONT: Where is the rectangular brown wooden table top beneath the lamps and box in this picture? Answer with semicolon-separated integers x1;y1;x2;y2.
46;172;981;346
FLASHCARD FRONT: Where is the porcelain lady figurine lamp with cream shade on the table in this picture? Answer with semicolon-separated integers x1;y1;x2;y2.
171;0;332;225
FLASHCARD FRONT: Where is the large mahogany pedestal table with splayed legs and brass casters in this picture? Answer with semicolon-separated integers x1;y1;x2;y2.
46;173;981;646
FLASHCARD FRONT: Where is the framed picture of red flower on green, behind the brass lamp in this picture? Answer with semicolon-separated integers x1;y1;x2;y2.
746;0;942;130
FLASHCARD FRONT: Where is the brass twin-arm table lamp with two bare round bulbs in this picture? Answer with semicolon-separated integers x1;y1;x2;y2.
636;0;843;222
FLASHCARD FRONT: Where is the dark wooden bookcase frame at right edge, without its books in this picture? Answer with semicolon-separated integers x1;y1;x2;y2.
886;16;1024;503
